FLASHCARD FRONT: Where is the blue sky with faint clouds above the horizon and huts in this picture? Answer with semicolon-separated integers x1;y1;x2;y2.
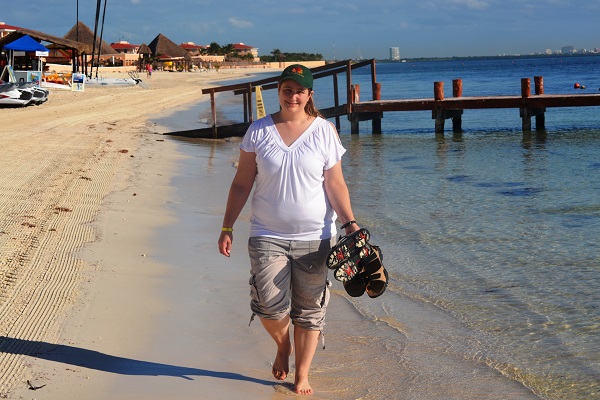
0;0;600;60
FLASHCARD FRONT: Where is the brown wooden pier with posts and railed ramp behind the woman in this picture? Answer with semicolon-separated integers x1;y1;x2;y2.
167;59;600;139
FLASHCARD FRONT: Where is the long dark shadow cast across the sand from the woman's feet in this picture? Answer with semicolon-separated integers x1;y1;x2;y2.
0;336;275;386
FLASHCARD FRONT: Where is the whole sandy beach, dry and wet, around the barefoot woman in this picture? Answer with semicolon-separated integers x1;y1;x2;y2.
0;70;536;400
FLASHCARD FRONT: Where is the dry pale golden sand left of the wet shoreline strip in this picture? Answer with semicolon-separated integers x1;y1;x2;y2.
0;70;282;399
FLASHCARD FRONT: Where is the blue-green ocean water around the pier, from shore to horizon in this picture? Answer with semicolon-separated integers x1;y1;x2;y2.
156;57;600;399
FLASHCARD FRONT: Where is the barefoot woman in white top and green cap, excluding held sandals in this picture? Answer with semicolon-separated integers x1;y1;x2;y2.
219;64;359;395
